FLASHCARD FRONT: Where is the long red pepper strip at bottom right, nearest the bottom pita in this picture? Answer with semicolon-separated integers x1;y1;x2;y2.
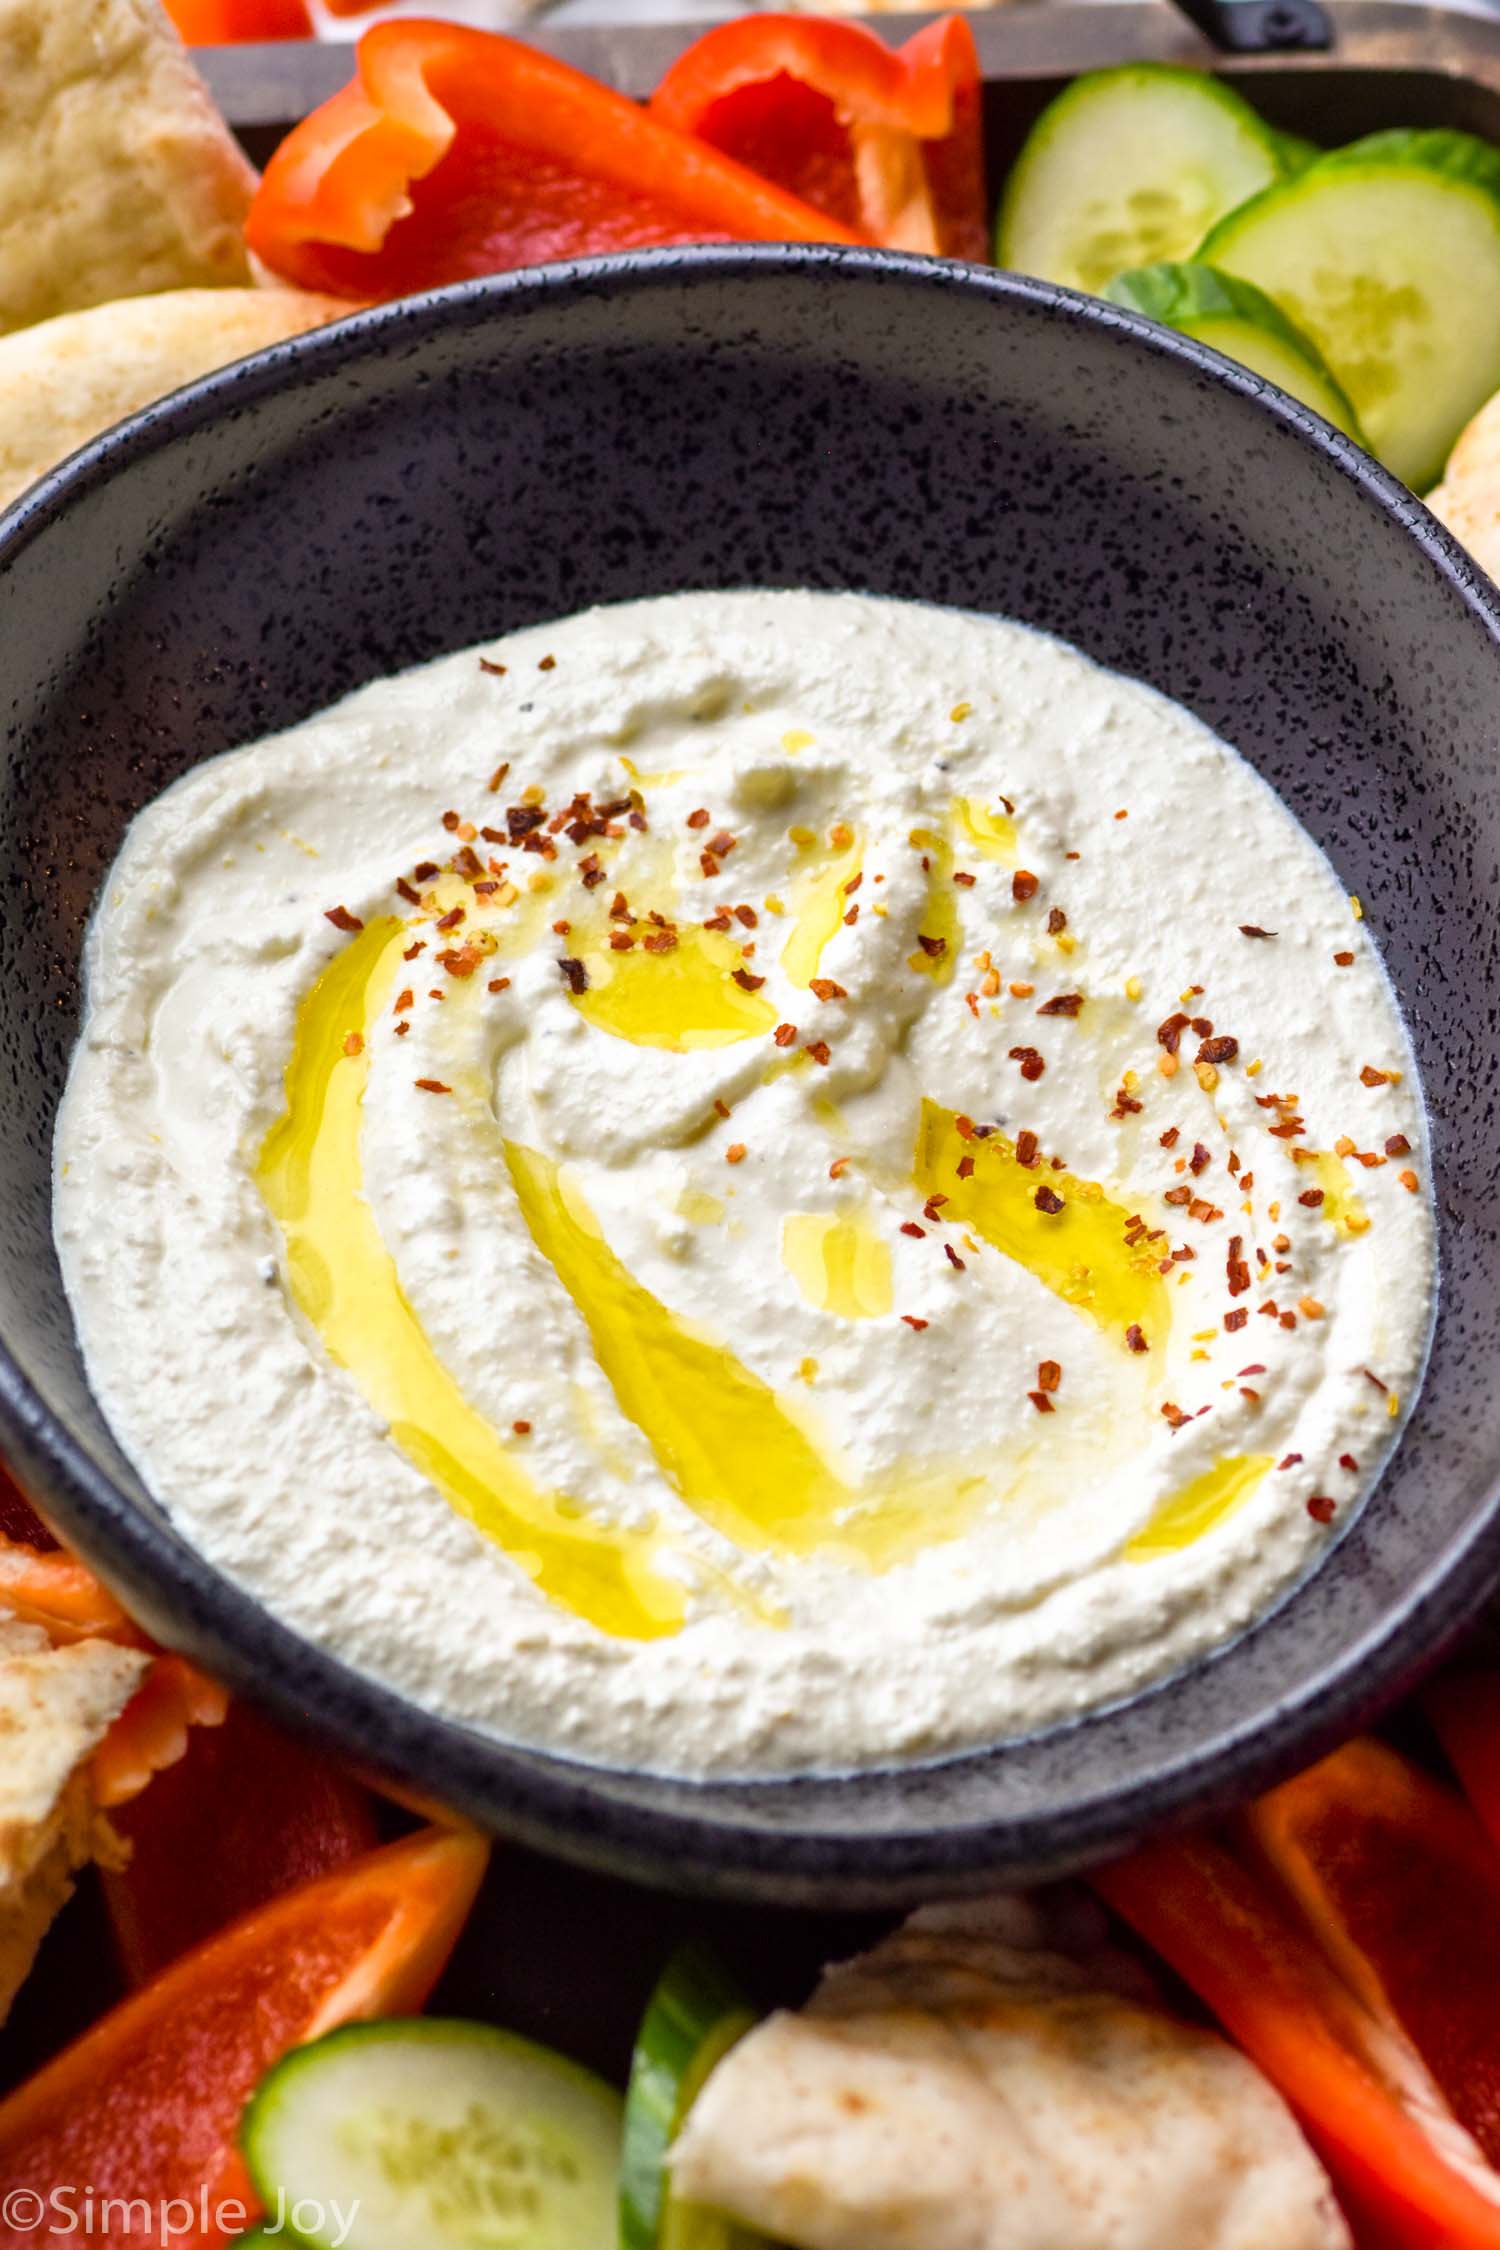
1093;1809;1500;2250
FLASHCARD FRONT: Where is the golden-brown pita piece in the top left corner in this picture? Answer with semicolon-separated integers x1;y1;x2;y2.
0;0;254;331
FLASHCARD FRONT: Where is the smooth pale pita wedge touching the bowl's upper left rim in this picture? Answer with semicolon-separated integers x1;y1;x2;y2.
0;283;358;506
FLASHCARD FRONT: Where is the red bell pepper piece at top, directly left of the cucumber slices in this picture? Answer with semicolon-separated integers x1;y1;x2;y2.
650;16;990;259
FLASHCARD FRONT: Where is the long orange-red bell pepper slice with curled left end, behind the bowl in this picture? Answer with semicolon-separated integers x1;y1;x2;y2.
245;20;857;299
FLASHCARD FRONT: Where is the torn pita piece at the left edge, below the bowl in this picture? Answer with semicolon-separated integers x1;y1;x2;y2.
0;1616;151;2021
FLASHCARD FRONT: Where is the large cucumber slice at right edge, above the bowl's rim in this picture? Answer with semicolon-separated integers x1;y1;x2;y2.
1199;133;1500;491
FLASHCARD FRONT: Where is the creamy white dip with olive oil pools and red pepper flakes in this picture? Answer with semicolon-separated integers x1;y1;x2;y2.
56;594;1435;1773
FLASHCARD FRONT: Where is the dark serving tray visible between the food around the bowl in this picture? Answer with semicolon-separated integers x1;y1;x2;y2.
0;0;1500;2088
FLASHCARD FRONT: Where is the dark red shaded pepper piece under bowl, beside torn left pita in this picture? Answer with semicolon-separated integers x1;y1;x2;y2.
103;1703;378;1985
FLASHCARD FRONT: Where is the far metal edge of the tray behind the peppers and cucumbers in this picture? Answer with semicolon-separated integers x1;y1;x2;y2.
208;0;1500;169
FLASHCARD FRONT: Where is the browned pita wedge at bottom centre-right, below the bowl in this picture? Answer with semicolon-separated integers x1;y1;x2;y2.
672;1901;1349;2250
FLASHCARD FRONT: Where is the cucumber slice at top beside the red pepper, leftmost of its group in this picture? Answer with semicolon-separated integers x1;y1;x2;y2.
994;63;1282;293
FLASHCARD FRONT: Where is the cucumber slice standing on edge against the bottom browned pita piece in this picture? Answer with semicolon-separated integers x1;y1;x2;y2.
621;1944;756;2250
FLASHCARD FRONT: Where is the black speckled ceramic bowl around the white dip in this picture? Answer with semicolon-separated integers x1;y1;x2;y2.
0;248;1500;1906
